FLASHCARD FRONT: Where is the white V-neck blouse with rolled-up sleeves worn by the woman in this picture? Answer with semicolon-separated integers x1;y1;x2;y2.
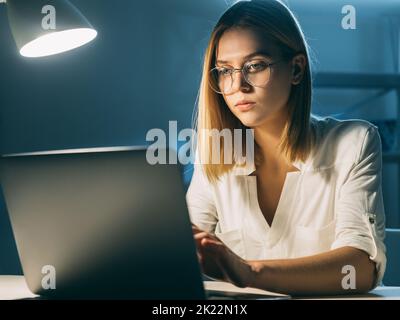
186;118;386;284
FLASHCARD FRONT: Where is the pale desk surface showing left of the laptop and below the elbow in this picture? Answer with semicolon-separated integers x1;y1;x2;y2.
0;276;400;300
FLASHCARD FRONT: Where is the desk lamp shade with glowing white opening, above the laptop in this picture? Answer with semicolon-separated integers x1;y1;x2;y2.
7;0;97;57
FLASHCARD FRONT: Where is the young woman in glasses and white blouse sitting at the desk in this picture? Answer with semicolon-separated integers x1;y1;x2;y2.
187;0;386;295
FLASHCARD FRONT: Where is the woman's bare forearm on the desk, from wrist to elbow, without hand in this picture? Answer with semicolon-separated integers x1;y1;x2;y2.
248;247;376;295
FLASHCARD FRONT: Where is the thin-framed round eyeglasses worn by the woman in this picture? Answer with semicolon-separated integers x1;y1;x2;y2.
209;59;283;94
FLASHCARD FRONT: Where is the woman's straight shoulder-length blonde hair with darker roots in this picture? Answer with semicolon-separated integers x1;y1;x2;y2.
195;0;314;182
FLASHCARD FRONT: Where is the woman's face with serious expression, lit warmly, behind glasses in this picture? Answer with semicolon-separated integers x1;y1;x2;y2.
216;28;304;128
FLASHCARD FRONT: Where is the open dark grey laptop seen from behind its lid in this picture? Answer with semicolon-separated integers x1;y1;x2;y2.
0;147;290;299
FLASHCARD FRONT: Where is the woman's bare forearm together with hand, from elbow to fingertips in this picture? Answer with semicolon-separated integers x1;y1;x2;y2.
193;228;376;295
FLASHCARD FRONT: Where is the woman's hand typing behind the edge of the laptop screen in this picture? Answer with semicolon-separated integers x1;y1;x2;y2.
192;225;252;287
